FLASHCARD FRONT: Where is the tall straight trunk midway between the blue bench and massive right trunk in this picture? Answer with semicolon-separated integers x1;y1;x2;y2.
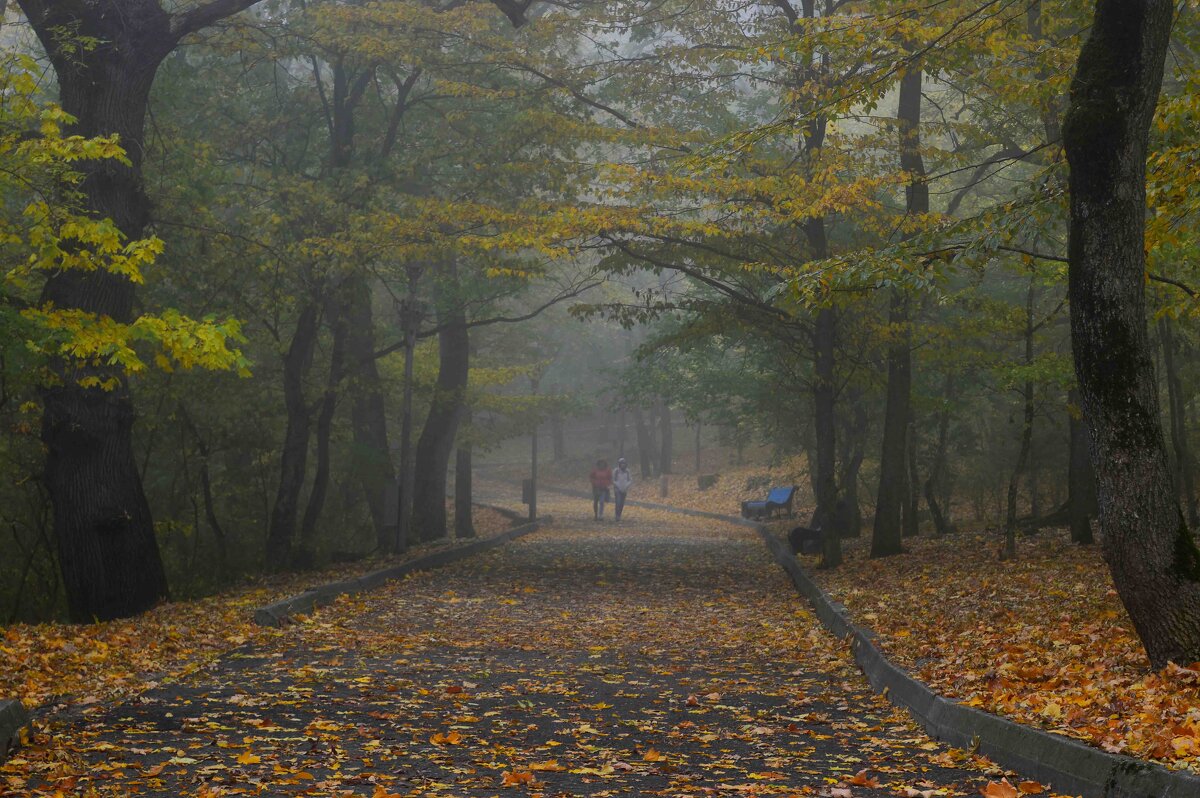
871;64;929;557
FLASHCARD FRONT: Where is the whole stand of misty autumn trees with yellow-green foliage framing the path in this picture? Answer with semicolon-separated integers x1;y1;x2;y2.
0;0;1200;676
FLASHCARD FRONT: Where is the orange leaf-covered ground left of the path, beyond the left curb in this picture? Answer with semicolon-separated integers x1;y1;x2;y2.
0;509;510;710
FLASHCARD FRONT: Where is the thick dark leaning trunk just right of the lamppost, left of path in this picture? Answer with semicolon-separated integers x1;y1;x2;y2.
413;306;470;540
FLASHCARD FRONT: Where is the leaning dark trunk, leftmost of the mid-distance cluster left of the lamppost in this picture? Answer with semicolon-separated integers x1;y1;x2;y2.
266;302;318;570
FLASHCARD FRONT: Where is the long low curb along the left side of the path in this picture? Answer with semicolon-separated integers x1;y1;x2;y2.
254;516;552;626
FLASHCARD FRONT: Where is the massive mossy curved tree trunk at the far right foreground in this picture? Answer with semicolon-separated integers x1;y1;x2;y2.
1063;0;1200;667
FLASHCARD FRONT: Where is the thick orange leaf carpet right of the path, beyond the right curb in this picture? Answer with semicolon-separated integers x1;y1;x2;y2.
815;530;1200;772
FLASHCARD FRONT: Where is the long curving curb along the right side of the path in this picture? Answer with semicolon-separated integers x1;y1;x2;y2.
557;491;1200;798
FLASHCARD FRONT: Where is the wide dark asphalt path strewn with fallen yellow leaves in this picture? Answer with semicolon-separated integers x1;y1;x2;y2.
0;497;1049;798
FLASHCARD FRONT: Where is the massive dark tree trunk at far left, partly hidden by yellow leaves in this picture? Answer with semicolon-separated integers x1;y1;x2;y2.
20;0;180;623
